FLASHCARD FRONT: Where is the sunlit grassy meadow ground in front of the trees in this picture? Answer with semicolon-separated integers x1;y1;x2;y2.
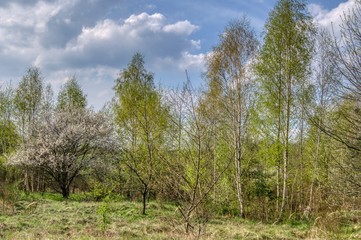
0;194;361;239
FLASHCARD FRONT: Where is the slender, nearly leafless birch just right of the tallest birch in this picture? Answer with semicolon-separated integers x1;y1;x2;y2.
306;29;340;214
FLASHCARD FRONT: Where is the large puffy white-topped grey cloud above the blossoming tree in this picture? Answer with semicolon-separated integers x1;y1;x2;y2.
36;13;201;71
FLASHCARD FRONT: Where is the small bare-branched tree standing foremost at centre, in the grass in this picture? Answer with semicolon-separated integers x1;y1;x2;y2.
166;74;232;234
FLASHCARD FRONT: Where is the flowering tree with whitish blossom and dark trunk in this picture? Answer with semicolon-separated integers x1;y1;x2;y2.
11;109;115;198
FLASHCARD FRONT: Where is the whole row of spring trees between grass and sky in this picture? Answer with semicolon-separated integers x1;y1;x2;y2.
0;0;361;231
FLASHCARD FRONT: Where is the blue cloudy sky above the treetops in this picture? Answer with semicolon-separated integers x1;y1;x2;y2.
0;0;355;109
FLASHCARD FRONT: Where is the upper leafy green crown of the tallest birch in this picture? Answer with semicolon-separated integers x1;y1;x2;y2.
256;0;314;124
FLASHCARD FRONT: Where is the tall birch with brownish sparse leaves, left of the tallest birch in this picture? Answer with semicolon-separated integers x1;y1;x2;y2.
202;17;258;218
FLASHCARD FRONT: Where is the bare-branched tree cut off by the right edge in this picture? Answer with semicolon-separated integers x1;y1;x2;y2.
308;0;361;196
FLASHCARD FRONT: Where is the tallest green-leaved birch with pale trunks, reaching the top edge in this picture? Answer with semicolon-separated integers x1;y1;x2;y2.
256;0;315;220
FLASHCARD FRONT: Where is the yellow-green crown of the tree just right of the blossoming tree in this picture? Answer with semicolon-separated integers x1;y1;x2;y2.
115;53;168;135
